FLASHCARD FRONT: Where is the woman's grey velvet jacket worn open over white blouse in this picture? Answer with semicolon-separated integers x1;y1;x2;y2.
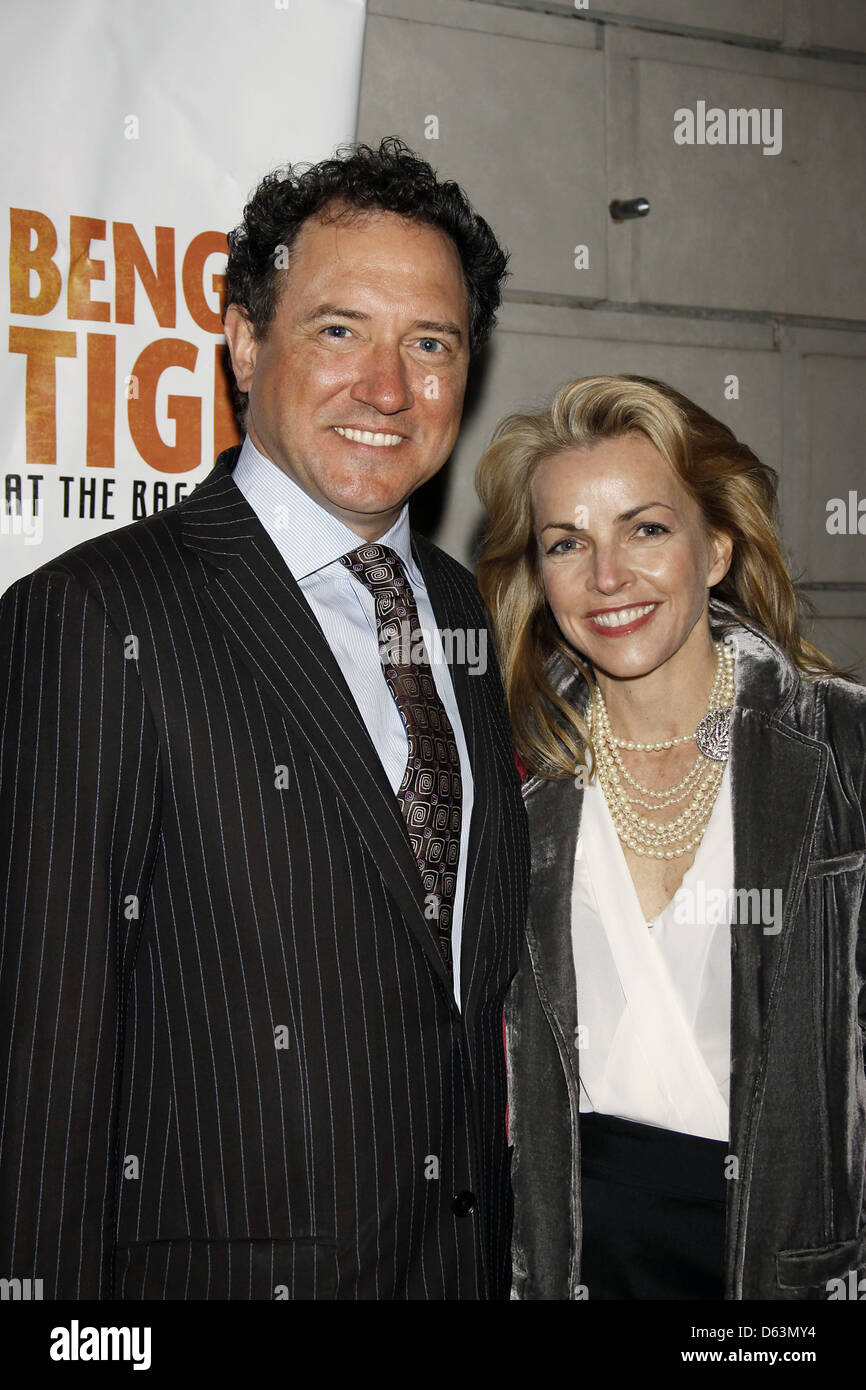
506;603;866;1300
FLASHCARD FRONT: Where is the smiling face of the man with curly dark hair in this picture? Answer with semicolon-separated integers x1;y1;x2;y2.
219;213;468;541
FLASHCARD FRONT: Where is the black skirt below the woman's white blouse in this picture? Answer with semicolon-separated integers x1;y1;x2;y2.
580;1112;728;1301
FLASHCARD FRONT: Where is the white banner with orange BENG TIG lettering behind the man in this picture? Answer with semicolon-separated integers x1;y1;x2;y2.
0;0;364;592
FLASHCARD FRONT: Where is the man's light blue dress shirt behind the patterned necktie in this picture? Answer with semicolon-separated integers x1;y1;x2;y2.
232;435;473;1006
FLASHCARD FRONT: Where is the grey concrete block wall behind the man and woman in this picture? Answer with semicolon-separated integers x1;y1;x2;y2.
359;0;866;678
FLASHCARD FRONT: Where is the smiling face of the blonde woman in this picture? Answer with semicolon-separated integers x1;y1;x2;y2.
531;434;731;678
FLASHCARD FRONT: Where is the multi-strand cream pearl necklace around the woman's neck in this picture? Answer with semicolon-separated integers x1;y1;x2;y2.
587;642;734;859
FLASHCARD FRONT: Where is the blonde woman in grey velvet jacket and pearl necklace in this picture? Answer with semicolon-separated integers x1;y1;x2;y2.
478;377;866;1300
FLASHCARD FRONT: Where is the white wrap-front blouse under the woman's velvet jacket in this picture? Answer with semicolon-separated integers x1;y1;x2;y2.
571;765;734;1140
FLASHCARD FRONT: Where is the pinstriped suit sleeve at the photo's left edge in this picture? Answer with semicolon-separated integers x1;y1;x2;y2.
0;567;160;1298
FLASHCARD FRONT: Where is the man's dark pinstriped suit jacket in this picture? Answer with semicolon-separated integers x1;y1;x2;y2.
0;450;528;1298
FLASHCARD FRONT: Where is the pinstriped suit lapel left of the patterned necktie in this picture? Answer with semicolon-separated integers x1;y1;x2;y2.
182;450;452;994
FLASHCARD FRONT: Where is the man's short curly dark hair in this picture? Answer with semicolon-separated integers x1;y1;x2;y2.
225;135;507;356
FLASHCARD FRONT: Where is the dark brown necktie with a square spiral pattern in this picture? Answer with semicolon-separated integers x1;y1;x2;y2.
341;542;461;965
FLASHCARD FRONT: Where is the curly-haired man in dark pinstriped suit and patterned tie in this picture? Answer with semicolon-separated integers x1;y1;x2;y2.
0;140;528;1298
